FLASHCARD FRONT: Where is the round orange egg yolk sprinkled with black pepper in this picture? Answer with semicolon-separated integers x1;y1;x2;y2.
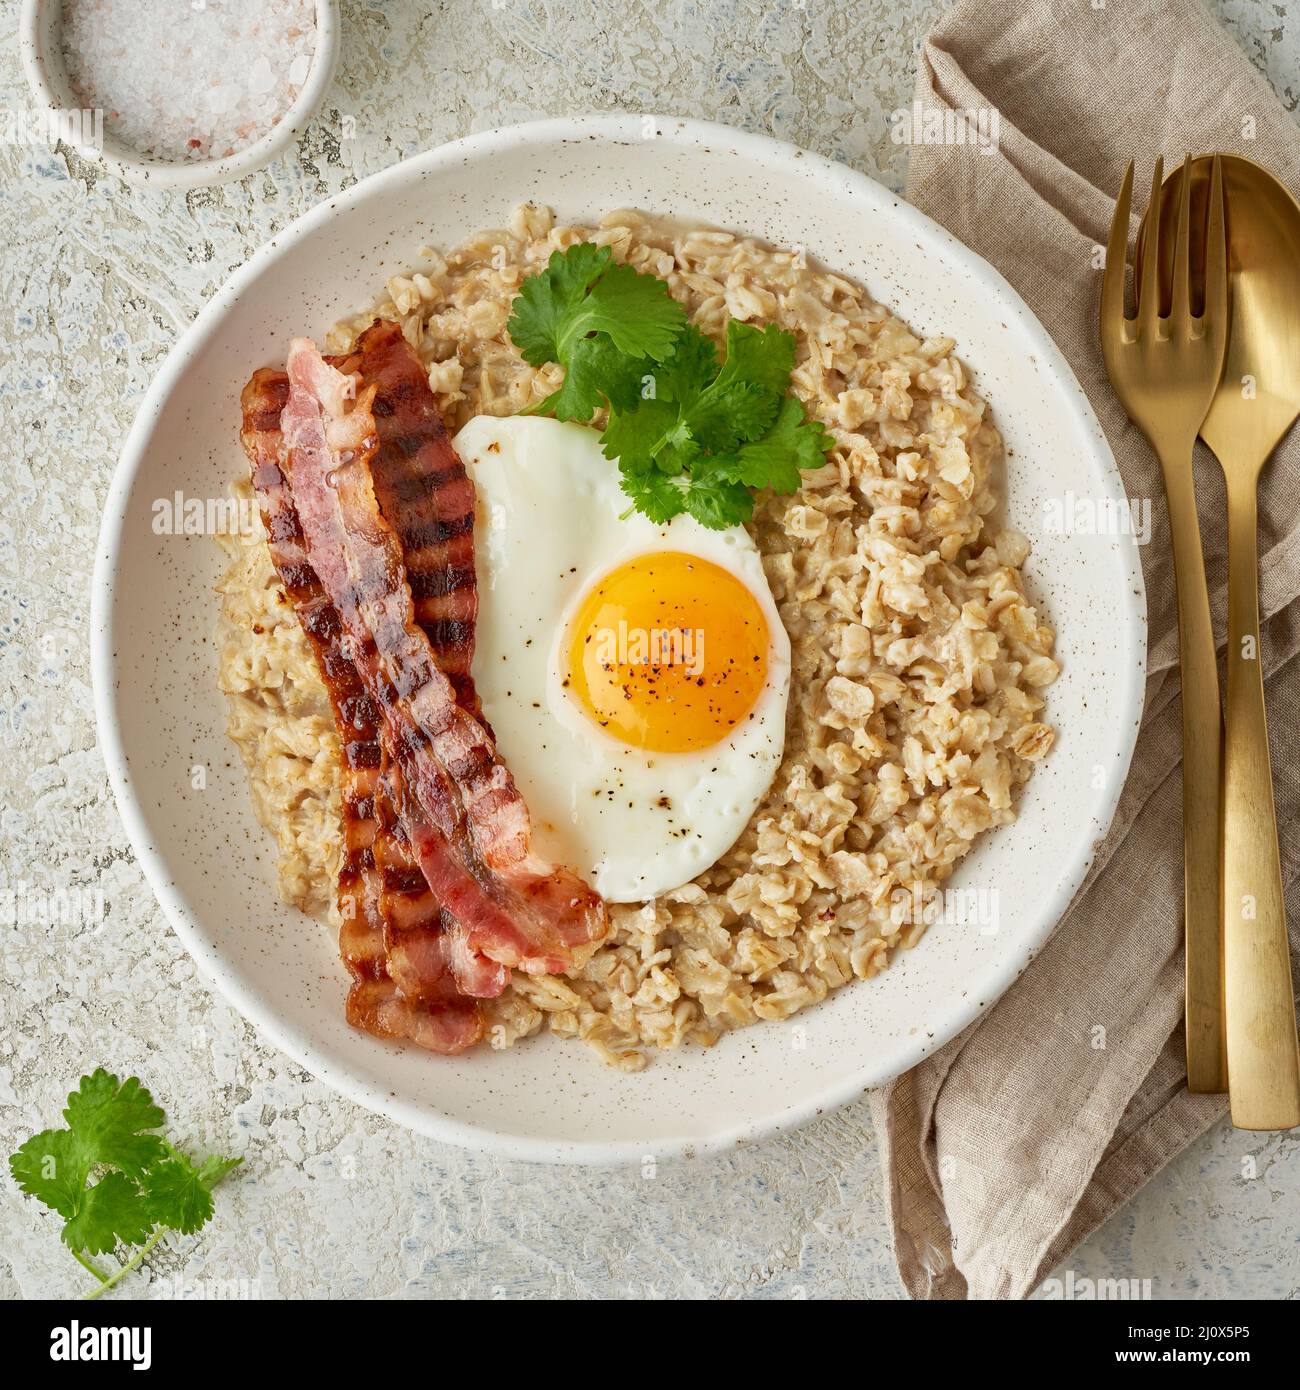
567;550;770;753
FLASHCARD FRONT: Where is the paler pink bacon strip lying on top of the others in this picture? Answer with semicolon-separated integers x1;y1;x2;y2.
281;339;609;991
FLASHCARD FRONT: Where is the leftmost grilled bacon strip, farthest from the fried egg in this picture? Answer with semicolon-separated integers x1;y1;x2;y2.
241;368;482;1052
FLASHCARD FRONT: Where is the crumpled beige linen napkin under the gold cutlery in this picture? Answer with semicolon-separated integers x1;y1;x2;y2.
872;0;1300;1298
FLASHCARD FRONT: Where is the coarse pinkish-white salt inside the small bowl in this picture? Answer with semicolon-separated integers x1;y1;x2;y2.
63;0;316;160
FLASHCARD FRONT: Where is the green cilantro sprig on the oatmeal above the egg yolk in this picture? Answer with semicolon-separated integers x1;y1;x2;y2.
507;242;833;530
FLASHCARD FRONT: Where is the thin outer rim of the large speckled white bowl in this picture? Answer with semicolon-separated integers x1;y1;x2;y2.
90;115;1147;1165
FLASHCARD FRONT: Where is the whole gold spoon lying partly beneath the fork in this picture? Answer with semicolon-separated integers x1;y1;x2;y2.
1145;154;1300;1130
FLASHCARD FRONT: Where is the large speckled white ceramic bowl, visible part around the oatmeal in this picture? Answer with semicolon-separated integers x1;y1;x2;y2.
92;117;1146;1162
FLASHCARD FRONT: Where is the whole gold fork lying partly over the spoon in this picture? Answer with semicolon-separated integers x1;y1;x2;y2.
1101;156;1228;1093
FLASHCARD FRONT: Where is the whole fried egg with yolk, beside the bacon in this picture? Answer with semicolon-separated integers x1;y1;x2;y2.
453;416;790;902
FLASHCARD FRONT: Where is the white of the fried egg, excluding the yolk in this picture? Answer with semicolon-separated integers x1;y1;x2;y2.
453;416;790;902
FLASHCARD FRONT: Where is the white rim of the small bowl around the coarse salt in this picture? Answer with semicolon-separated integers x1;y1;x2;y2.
18;0;339;188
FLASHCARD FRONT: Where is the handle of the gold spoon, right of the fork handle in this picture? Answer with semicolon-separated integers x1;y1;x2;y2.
1224;470;1300;1130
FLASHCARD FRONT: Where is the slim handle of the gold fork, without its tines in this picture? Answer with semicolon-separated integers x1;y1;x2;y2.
1161;442;1228;1094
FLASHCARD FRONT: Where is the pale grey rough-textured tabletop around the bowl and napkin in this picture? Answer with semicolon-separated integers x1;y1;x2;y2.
0;0;1300;1298
